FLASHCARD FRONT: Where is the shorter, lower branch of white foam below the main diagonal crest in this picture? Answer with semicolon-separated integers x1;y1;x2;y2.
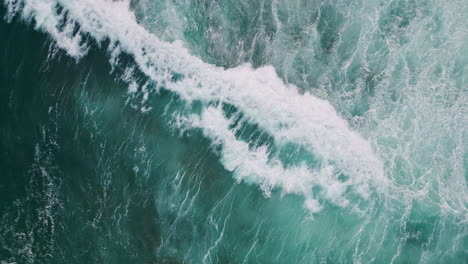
185;107;365;212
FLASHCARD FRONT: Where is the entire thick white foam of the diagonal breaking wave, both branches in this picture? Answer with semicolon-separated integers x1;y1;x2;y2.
5;0;387;211
